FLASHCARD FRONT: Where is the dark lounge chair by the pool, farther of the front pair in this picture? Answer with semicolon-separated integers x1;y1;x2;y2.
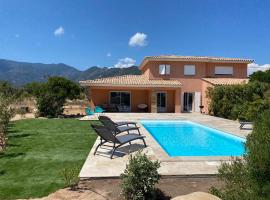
98;116;141;135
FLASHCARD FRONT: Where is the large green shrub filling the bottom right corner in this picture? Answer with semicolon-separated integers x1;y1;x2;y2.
210;110;270;200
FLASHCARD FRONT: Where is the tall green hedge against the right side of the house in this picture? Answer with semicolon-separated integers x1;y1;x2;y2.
207;82;270;121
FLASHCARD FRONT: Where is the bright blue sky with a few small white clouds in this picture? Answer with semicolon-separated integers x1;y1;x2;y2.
0;0;270;70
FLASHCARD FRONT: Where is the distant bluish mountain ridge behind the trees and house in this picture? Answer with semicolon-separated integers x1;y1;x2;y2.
0;59;141;86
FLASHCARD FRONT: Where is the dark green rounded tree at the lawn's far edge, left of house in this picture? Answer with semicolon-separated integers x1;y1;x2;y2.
35;77;81;117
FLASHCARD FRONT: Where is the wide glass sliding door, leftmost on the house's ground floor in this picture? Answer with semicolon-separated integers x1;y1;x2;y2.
110;91;131;112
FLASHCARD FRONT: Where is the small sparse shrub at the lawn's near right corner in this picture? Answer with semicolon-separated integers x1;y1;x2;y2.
61;166;80;190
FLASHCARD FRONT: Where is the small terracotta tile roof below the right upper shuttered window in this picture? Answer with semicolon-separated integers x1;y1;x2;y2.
202;78;248;85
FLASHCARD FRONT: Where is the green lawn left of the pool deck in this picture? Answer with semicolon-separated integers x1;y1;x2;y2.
0;119;96;199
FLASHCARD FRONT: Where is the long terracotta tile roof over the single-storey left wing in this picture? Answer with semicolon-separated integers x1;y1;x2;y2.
80;75;181;87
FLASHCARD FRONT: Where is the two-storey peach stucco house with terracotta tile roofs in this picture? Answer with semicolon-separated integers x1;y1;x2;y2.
80;55;253;113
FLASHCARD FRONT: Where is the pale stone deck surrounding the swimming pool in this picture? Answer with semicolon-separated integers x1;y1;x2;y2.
80;113;251;179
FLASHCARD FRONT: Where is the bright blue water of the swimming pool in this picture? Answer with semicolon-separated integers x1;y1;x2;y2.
141;120;245;156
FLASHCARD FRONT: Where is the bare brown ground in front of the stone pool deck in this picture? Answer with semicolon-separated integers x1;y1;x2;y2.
30;177;221;200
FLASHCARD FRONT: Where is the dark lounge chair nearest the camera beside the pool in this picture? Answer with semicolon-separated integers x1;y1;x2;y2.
91;125;146;159
